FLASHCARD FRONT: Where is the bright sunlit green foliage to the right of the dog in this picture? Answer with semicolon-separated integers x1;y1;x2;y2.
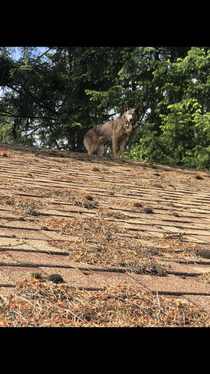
124;47;210;169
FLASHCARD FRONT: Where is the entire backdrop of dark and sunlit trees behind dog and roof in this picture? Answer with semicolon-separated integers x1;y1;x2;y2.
0;46;210;169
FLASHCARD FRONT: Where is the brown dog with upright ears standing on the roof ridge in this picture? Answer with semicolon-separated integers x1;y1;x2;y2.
84;103;140;158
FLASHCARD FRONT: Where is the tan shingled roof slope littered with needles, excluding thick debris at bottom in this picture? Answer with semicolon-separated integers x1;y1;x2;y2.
0;143;210;326
